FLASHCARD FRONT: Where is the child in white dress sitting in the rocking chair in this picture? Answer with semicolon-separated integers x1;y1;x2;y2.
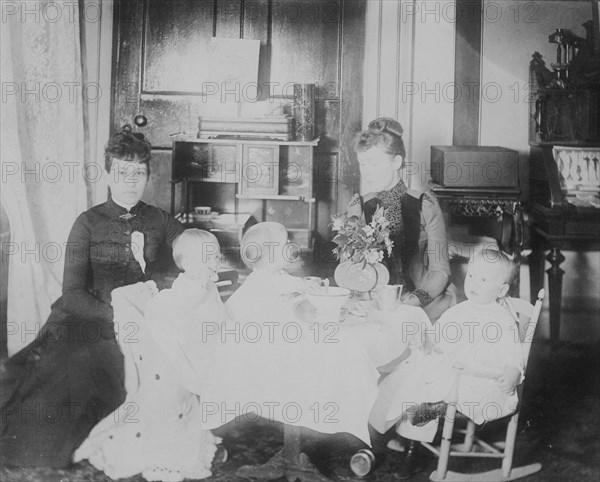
369;249;524;475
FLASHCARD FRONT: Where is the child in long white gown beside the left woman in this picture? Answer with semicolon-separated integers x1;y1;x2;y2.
74;229;225;482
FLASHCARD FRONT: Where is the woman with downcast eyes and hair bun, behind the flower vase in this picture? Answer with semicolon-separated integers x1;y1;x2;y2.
348;117;454;320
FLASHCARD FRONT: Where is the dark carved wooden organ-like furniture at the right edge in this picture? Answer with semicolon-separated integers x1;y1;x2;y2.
527;27;600;346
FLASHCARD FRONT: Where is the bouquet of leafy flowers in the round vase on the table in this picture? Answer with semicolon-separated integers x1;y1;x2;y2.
331;207;393;265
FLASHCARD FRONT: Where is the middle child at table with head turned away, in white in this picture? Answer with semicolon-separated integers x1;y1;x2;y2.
225;222;319;323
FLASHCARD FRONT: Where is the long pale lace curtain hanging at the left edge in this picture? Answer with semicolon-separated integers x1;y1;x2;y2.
0;0;88;355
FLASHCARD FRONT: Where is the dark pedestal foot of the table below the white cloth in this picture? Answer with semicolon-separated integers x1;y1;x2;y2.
236;424;331;482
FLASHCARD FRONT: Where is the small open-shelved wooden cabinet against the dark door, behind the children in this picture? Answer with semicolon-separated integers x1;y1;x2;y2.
171;137;319;248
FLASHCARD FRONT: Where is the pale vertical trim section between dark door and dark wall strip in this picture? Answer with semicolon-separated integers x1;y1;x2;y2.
363;0;456;189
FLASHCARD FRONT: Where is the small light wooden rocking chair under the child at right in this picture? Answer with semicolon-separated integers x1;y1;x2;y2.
421;289;545;482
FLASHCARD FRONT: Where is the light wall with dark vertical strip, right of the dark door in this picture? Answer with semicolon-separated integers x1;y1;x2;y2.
363;0;600;342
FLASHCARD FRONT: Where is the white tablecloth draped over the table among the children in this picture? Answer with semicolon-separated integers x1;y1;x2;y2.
113;284;431;444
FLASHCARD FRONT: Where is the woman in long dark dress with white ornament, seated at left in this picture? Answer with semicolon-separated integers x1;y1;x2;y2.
0;126;184;467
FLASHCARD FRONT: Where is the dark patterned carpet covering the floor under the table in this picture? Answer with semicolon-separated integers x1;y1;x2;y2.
0;342;600;482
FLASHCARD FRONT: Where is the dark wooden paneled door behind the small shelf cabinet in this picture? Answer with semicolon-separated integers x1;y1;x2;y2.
112;0;366;236
